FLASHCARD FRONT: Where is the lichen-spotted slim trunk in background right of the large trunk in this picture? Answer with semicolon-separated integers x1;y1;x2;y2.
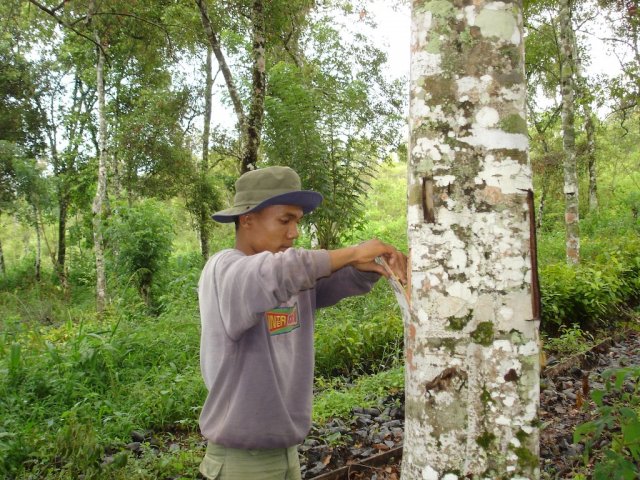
559;0;580;264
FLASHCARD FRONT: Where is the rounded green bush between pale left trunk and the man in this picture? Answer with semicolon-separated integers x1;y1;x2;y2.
106;199;173;304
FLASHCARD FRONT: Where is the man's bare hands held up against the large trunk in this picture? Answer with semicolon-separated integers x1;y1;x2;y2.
329;239;407;284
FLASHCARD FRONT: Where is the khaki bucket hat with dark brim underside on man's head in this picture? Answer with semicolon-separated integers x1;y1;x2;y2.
211;167;322;223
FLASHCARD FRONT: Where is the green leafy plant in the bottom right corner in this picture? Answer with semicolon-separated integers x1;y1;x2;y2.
573;366;640;480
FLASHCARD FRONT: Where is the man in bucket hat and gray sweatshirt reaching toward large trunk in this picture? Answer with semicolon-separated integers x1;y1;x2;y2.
198;167;406;480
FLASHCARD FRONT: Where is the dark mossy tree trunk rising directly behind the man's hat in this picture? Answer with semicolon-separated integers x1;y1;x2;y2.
242;0;266;173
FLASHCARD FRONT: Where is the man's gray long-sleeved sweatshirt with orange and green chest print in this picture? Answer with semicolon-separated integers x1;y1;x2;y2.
198;248;379;449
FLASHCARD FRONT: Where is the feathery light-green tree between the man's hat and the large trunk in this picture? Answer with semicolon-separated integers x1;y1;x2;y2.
263;19;402;248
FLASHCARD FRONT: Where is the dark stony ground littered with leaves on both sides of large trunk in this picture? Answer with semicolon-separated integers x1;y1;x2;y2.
292;332;640;480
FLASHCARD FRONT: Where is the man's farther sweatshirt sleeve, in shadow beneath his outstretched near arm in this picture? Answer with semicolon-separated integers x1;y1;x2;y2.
316;267;380;308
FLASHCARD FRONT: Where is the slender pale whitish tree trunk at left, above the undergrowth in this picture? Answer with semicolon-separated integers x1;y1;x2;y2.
92;33;108;314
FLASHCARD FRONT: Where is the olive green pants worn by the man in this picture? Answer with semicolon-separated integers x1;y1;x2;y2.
200;442;302;480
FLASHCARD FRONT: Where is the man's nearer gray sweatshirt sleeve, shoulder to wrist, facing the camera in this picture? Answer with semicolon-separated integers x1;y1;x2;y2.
198;248;331;340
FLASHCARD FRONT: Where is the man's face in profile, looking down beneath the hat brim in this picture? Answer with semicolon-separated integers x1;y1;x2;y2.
240;205;302;253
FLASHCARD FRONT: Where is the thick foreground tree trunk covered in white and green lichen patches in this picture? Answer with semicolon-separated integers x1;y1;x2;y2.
402;0;540;480
